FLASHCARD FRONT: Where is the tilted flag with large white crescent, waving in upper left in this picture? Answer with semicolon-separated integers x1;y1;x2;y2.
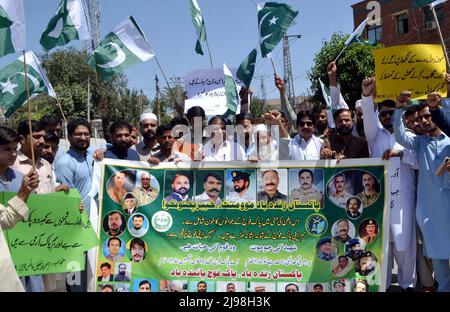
88;16;155;80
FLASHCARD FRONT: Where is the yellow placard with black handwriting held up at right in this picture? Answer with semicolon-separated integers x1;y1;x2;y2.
375;44;447;102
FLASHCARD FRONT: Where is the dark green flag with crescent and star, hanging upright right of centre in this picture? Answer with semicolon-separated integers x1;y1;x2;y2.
258;2;298;57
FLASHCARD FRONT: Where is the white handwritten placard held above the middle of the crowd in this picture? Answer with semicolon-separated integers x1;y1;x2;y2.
184;68;242;116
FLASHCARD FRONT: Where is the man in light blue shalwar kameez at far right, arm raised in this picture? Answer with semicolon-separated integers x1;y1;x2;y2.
393;94;450;291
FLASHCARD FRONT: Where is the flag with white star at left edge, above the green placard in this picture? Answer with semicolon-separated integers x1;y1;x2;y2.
0;51;56;117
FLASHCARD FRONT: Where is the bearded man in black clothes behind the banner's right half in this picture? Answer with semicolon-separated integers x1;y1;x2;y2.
320;108;369;160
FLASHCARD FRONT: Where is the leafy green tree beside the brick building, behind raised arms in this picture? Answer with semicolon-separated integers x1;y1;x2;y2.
307;33;380;108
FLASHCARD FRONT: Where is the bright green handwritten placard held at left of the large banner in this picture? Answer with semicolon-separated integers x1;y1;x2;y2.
1;189;98;276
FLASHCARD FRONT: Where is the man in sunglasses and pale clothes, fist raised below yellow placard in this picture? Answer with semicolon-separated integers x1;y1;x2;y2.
357;78;418;290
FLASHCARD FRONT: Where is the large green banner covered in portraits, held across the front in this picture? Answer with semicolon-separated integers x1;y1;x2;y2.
95;159;392;292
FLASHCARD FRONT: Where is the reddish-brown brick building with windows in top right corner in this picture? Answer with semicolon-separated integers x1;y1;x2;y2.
352;0;450;51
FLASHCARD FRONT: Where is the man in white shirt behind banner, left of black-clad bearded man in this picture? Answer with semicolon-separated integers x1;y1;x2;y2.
289;111;323;160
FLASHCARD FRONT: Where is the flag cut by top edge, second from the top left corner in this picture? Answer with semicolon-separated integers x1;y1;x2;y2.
40;0;91;50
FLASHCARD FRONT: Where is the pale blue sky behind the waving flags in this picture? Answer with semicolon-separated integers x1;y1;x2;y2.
0;0;359;99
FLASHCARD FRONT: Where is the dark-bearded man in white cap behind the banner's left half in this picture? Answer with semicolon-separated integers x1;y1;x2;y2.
132;112;159;161
